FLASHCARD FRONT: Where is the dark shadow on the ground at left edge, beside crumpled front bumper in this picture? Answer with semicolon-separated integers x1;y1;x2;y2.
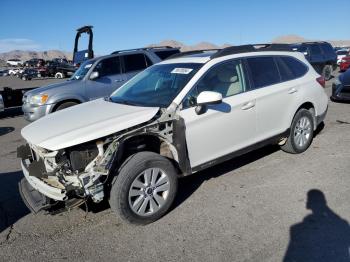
0;171;29;233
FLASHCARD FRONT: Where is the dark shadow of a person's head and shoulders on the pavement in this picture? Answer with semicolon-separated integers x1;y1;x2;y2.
283;189;350;262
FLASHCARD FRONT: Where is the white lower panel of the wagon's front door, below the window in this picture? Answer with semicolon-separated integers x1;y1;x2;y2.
180;91;256;168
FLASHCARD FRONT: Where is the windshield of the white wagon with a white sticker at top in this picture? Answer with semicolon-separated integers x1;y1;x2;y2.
110;63;202;108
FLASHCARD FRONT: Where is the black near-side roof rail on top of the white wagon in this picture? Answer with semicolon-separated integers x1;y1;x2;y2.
210;44;292;59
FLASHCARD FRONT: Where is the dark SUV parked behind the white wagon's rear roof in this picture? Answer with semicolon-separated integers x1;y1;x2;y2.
292;42;337;80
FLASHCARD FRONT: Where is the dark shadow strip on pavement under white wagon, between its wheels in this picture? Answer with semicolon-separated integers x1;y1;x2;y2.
171;145;280;211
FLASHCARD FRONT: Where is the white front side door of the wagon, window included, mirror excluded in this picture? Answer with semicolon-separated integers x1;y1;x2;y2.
180;59;256;168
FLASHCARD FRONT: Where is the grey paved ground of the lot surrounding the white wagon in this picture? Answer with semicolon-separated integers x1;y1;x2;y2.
0;72;350;261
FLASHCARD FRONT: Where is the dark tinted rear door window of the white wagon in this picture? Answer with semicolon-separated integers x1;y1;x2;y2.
247;56;280;88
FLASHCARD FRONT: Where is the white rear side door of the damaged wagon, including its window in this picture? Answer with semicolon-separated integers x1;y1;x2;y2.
247;56;299;141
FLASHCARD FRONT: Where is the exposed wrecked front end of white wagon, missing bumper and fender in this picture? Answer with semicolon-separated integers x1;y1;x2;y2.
17;107;190;214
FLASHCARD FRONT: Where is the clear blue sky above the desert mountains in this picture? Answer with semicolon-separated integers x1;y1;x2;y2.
0;0;350;54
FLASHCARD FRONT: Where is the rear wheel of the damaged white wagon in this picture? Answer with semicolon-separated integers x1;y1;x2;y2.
281;108;314;154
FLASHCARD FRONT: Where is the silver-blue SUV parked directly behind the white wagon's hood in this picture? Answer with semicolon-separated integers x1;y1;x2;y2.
22;46;180;121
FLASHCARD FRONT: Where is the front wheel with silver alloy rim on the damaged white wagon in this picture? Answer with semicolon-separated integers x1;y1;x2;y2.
109;152;177;225
